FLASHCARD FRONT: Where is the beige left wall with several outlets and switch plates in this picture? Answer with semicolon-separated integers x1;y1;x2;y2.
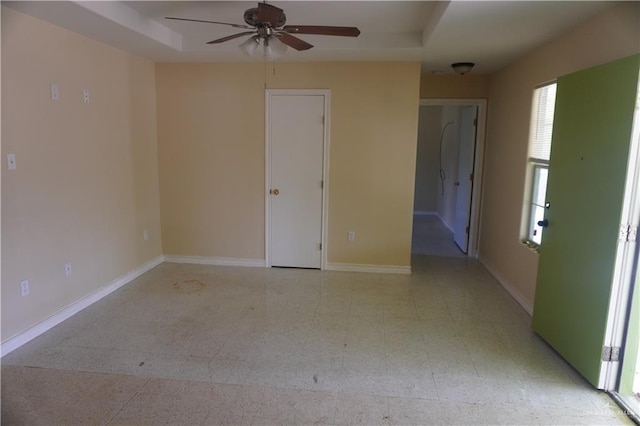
2;8;161;341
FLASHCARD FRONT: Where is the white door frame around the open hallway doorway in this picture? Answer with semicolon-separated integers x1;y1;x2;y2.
420;98;487;258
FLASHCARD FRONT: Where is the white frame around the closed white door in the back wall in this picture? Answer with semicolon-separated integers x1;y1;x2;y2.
264;89;331;269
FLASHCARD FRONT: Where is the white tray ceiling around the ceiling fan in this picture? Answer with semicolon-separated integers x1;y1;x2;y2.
2;0;614;73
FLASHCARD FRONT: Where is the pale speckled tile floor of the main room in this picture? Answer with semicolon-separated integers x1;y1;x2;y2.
1;256;630;425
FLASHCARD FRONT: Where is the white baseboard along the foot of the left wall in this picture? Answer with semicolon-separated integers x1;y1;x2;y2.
0;256;163;356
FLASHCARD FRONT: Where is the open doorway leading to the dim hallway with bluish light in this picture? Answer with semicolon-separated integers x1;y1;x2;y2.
411;99;486;257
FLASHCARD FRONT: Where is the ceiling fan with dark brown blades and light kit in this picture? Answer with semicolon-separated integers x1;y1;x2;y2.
166;3;360;56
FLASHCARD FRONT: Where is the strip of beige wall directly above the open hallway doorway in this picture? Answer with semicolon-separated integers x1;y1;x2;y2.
420;71;490;99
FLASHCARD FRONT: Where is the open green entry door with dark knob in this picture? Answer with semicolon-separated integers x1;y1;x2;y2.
533;55;640;387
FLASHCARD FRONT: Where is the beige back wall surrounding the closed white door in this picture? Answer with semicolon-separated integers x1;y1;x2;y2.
156;63;420;266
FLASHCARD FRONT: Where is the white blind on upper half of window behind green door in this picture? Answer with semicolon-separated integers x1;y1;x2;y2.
529;83;557;164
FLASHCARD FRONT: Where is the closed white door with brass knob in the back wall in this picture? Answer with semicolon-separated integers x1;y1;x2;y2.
268;94;325;268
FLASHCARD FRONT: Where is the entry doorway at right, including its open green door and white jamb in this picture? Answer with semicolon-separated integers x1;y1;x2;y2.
532;55;640;420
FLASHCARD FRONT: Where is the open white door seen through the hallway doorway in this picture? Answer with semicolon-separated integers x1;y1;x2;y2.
453;106;478;253
